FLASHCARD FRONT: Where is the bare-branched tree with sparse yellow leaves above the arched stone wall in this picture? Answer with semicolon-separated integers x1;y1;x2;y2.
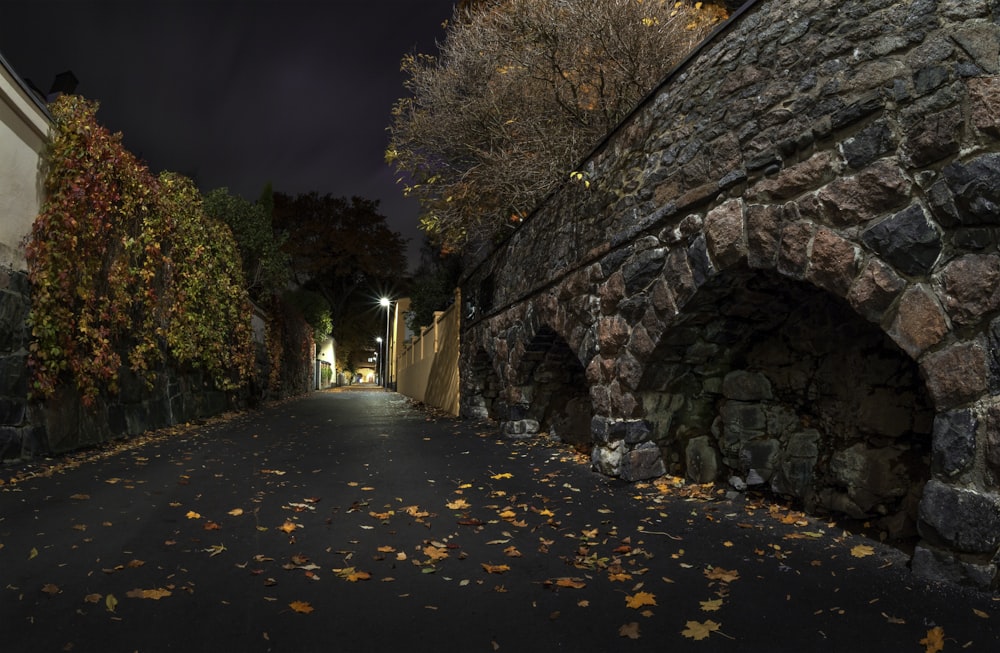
386;0;726;249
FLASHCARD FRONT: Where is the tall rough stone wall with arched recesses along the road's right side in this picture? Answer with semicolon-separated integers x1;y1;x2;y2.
462;0;1000;586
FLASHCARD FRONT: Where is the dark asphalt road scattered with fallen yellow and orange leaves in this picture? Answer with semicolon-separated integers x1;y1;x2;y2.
0;390;1000;653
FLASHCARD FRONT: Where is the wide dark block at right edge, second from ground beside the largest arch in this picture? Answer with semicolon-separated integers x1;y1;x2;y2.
919;479;1000;555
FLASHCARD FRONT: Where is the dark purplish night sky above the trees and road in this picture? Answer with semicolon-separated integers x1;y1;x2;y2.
0;0;454;264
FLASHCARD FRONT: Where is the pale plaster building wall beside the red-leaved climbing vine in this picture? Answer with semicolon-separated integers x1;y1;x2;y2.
0;57;51;271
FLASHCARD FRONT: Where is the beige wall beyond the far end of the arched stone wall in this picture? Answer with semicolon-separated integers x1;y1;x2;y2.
396;291;461;415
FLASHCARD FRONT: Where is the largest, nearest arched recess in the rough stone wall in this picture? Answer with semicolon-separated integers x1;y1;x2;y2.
639;266;934;540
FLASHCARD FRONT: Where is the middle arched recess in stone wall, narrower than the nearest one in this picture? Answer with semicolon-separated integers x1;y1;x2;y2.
505;326;594;451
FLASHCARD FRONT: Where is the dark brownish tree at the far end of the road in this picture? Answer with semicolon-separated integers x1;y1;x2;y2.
274;192;406;360
